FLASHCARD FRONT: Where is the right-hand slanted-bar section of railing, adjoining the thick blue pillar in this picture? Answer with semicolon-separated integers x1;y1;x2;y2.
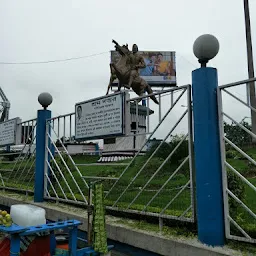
105;85;194;221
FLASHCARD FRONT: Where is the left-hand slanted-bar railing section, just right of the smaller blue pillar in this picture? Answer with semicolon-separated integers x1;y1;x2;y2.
44;113;89;204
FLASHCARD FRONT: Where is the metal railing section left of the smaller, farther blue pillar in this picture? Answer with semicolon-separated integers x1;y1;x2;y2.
0;119;36;194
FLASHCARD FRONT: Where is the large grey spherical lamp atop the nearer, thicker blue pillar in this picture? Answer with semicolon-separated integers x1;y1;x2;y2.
193;34;220;67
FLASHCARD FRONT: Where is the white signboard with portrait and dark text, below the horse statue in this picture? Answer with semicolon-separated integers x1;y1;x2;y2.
75;92;125;139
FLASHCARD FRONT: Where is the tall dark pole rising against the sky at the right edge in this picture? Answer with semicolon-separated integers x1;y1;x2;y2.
244;0;256;139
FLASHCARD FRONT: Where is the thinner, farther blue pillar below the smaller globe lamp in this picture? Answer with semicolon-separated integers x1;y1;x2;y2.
34;110;51;203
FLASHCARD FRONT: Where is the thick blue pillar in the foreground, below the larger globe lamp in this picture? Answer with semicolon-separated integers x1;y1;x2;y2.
192;67;225;246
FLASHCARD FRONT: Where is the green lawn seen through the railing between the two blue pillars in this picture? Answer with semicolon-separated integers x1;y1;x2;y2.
46;156;191;216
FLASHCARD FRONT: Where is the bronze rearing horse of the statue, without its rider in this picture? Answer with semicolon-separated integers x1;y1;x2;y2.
106;40;159;104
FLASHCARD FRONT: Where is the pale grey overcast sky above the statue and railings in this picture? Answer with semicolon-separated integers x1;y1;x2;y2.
0;0;256;134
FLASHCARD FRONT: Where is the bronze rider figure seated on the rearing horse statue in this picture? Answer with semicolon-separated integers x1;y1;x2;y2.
128;44;146;88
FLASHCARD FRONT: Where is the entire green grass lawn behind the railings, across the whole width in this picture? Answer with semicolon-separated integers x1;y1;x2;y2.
0;148;256;238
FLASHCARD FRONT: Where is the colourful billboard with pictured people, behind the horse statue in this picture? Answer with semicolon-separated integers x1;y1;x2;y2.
111;51;176;86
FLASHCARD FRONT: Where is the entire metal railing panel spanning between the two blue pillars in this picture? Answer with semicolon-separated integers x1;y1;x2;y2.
45;85;195;222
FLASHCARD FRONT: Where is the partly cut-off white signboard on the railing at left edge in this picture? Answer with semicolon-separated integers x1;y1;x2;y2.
0;118;21;146
